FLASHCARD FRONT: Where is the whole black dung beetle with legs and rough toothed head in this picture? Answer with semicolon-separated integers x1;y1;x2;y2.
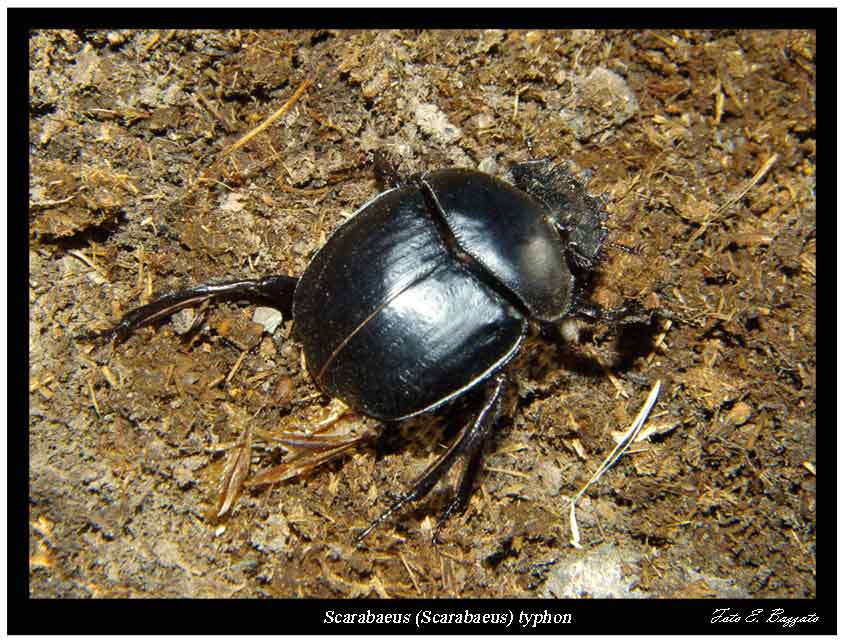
85;155;639;541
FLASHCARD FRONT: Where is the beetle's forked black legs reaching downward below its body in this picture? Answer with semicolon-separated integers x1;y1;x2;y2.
355;374;506;543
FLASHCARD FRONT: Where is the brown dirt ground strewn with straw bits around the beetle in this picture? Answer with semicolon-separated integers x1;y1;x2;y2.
29;30;816;598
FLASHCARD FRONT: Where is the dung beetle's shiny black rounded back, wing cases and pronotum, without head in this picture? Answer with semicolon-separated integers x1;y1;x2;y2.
293;169;573;421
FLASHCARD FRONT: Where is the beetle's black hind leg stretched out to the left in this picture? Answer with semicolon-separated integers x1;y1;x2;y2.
80;275;299;341
